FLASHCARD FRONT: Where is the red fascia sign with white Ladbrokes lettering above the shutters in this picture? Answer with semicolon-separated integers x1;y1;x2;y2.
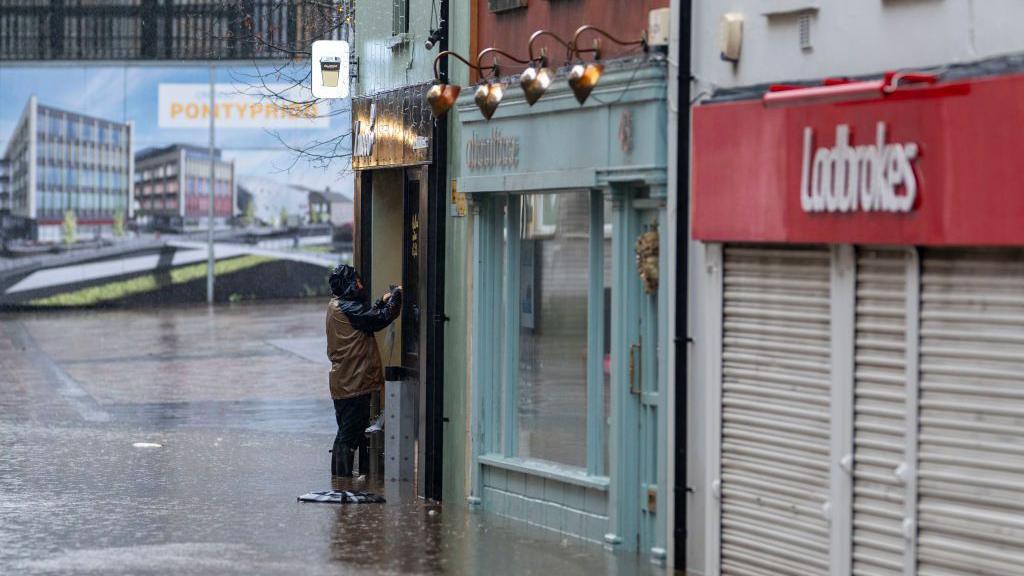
692;76;1024;245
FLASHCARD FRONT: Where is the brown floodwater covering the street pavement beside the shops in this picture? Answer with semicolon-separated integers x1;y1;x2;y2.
0;302;657;576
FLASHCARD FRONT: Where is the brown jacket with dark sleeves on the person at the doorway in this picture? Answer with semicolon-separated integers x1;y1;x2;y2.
327;297;401;400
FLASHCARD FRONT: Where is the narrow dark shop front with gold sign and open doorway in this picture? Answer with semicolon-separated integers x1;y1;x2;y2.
352;81;444;499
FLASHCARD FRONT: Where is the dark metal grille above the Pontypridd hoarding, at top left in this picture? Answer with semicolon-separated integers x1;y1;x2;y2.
0;0;349;60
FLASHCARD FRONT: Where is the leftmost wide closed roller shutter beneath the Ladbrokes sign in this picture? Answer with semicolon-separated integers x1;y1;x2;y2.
721;246;830;576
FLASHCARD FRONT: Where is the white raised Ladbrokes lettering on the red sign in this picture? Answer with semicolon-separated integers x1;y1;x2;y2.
800;122;920;212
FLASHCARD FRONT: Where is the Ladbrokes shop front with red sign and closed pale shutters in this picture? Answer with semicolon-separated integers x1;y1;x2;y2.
689;70;1024;576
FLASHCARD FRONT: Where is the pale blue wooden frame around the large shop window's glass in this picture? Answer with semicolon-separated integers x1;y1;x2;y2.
472;190;615;479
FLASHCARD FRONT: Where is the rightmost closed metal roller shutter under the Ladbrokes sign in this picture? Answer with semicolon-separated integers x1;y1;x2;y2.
918;250;1024;576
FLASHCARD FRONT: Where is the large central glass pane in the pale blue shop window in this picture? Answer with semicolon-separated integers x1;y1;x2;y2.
517;192;590;467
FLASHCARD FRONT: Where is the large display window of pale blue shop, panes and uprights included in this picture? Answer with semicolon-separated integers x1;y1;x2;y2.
475;191;611;478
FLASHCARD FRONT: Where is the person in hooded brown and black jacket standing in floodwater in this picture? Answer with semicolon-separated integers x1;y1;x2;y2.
327;264;401;477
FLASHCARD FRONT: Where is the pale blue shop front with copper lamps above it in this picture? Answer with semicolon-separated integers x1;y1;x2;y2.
456;58;669;554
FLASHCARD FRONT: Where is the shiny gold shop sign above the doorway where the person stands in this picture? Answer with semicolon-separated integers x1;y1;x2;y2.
352;84;433;170
